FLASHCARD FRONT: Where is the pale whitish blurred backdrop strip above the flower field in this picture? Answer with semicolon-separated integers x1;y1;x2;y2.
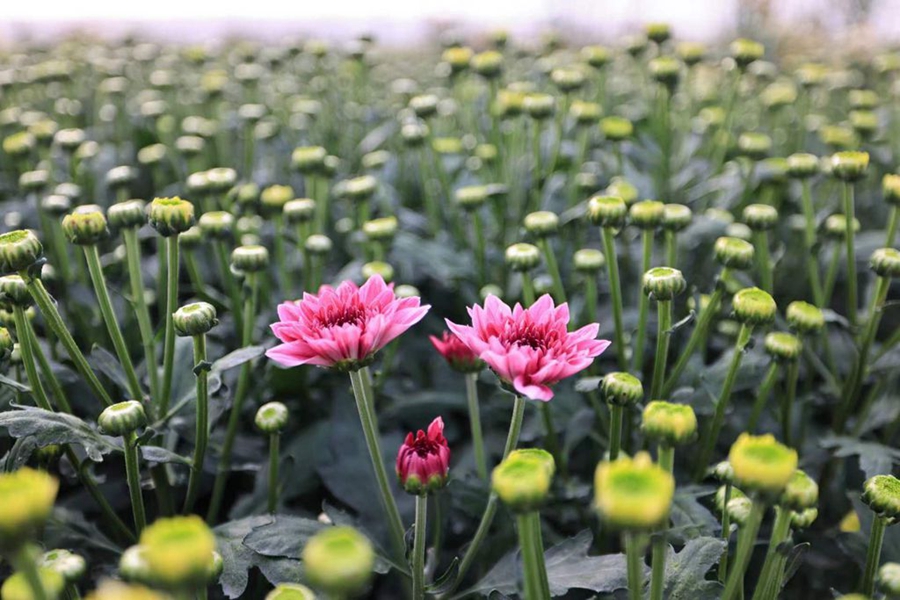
0;0;900;47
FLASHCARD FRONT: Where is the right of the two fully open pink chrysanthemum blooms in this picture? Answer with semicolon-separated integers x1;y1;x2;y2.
447;294;609;402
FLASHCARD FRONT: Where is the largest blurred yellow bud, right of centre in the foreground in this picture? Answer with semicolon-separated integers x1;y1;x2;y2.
594;452;675;531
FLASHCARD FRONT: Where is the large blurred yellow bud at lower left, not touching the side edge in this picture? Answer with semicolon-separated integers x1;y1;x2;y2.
140;515;216;589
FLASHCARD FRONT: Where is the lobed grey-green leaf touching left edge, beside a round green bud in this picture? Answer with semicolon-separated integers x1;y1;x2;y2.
0;407;118;462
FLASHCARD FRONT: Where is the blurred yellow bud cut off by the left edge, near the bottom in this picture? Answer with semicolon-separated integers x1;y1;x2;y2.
0;467;59;549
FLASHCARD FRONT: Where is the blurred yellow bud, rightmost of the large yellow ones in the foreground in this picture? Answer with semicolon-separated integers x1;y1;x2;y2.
728;433;797;494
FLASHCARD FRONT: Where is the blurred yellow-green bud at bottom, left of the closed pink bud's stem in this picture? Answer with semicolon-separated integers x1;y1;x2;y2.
301;527;375;597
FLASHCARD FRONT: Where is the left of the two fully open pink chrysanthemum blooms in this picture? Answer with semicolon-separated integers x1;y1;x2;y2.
266;275;430;371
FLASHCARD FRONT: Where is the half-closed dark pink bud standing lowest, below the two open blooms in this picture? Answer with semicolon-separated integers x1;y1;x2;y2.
397;417;450;495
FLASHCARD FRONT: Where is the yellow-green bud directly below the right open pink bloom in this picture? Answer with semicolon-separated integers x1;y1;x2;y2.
491;449;556;513
